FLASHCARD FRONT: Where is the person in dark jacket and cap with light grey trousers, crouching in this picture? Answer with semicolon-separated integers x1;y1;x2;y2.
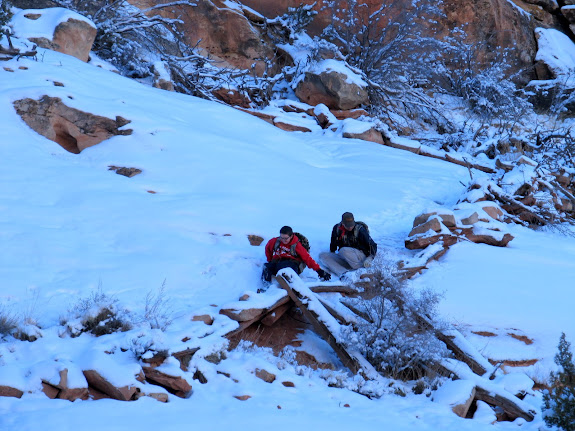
319;212;377;278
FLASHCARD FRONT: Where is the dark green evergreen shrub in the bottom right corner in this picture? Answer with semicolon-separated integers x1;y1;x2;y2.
543;333;575;431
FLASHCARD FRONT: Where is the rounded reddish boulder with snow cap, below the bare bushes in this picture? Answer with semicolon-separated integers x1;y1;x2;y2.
295;60;369;110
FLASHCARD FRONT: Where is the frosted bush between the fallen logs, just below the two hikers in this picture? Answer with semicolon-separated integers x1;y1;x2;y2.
343;265;448;379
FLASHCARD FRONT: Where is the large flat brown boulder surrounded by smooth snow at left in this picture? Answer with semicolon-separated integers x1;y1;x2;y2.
14;96;132;154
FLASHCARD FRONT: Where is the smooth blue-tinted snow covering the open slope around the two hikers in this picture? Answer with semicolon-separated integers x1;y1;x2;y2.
0;22;575;431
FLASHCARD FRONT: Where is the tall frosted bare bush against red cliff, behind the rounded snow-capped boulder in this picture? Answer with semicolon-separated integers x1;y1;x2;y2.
323;0;453;133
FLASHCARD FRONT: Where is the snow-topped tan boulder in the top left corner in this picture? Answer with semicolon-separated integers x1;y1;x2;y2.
11;7;97;61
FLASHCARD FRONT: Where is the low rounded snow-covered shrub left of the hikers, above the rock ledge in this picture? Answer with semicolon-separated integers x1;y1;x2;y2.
60;288;132;337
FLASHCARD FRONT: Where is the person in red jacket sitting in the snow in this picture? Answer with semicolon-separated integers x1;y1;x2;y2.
262;226;331;282
